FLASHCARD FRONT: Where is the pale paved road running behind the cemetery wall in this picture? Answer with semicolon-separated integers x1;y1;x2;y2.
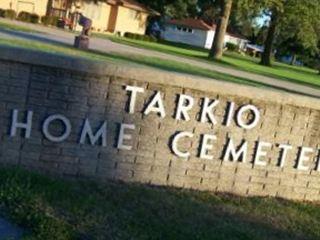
0;19;320;98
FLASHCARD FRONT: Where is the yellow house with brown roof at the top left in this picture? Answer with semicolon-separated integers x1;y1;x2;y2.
0;0;158;35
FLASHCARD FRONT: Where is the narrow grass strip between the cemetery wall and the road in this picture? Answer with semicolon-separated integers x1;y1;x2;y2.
0;39;271;87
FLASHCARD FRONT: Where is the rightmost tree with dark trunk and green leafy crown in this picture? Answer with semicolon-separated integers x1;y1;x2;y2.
261;0;320;66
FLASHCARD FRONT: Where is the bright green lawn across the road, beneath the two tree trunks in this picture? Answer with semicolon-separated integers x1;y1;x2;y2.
96;34;320;87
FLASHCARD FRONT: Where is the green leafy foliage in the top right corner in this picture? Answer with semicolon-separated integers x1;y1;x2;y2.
255;0;320;65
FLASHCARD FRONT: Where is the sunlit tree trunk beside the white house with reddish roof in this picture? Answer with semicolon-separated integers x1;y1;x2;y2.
209;0;233;59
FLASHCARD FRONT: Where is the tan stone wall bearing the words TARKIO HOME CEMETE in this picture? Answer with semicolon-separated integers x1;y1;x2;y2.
0;48;320;200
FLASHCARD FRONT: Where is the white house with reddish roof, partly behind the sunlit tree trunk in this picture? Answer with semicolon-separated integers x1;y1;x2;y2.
162;18;249;49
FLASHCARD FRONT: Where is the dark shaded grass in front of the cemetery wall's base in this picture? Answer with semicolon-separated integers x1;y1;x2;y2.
0;167;320;240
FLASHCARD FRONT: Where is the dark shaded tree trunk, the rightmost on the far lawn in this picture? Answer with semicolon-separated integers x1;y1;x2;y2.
260;9;278;66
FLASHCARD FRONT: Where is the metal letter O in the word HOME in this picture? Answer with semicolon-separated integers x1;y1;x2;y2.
42;114;71;142
